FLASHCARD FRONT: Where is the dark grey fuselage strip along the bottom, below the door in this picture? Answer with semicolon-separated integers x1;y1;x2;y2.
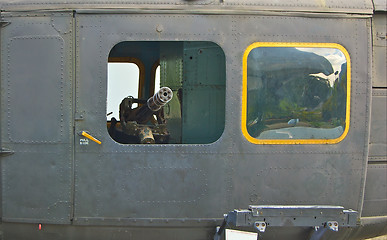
2;218;387;240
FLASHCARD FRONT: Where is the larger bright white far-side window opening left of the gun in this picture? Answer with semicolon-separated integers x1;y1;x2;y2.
106;62;140;119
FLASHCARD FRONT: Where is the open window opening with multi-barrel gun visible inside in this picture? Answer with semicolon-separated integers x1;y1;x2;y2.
107;41;226;144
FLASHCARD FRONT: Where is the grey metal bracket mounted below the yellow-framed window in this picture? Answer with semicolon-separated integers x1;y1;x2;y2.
214;205;358;240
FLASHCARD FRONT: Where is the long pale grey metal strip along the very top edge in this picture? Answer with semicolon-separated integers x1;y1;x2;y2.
0;0;373;14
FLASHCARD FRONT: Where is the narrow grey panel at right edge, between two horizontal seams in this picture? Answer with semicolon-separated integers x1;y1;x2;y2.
368;89;387;161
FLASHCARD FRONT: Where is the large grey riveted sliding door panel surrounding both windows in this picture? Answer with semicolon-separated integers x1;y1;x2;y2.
75;14;371;225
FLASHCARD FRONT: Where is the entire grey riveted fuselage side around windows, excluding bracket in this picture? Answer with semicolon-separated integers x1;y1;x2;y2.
0;0;385;239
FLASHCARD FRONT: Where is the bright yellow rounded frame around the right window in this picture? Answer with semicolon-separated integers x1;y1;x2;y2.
241;42;351;144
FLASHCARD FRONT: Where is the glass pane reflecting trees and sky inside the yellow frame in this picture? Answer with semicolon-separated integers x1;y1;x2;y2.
246;47;347;139
